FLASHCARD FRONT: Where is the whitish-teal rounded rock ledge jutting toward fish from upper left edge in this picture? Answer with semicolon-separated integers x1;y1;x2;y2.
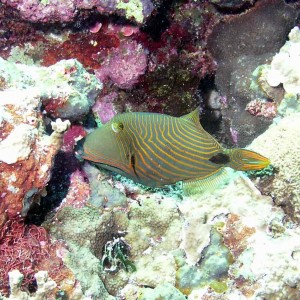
0;59;102;119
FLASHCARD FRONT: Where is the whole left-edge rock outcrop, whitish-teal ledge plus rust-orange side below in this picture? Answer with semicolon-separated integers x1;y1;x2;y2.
0;59;101;226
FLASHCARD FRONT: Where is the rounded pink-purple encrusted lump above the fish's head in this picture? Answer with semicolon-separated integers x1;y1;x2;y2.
95;41;147;89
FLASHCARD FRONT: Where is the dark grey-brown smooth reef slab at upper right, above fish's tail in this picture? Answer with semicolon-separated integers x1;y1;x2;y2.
208;0;297;146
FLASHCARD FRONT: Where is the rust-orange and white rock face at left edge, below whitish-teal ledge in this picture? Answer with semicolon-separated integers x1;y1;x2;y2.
0;90;70;227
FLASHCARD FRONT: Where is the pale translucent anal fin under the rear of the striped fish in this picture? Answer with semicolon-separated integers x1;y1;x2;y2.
182;168;227;196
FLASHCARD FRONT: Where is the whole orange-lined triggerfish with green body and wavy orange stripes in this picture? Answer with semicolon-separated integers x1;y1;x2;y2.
82;109;270;194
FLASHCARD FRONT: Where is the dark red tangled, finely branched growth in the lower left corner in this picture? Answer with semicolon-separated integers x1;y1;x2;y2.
0;218;49;294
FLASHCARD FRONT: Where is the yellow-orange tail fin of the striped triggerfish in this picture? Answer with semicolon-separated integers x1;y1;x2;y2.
224;149;270;171
